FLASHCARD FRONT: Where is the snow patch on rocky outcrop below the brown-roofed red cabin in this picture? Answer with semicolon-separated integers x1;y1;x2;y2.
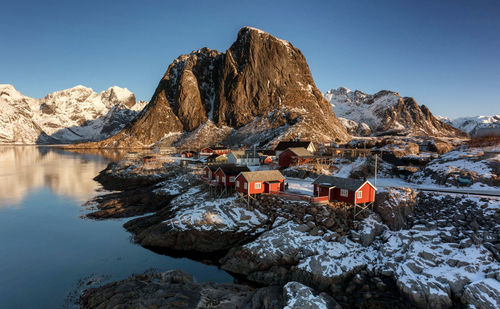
163;186;268;232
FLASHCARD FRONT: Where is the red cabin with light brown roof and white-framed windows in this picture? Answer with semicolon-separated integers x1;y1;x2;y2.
235;170;285;195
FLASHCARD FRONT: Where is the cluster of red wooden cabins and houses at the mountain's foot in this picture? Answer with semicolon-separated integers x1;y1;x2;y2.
142;141;378;219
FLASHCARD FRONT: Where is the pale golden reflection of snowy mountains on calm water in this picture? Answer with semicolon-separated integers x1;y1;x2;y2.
0;146;112;208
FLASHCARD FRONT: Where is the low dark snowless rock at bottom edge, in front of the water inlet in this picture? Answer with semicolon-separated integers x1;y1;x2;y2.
80;270;274;309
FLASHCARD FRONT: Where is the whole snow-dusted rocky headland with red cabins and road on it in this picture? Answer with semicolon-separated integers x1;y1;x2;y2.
80;135;500;308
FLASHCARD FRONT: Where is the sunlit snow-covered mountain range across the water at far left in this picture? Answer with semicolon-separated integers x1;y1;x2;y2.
0;84;146;144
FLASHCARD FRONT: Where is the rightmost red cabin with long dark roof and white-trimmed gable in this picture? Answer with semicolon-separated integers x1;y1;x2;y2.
313;175;377;205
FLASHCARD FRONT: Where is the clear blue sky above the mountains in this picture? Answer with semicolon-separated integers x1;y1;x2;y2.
0;0;500;117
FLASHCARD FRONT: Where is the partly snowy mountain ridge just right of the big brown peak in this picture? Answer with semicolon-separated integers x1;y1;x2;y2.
325;87;466;137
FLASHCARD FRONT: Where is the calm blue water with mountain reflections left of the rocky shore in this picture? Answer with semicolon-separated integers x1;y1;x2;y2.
0;146;233;308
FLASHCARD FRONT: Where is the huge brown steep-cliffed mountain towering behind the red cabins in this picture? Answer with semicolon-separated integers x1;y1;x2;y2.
88;27;349;148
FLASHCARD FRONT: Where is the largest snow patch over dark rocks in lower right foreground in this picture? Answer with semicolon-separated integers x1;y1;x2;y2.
227;197;500;308
